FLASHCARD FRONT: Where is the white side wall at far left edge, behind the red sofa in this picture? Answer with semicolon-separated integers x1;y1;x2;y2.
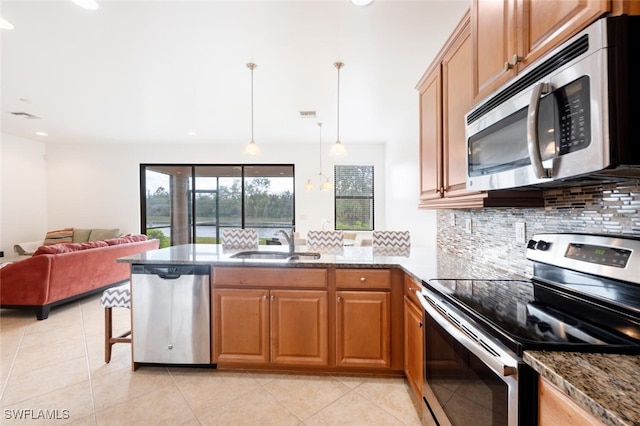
0;134;48;257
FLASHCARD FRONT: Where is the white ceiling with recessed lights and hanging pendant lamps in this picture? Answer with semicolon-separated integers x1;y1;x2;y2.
0;0;469;145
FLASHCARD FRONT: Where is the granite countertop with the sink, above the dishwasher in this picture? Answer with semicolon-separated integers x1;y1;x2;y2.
118;244;437;280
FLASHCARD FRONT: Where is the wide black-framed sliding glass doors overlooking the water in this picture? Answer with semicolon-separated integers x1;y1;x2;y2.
140;164;295;247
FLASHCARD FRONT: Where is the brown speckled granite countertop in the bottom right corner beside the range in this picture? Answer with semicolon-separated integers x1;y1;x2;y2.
523;351;640;425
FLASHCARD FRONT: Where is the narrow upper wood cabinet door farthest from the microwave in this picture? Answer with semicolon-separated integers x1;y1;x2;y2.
419;66;442;201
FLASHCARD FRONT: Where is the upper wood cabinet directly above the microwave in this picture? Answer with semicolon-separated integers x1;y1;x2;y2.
471;0;624;103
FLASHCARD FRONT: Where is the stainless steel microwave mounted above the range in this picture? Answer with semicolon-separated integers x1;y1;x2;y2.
465;16;640;190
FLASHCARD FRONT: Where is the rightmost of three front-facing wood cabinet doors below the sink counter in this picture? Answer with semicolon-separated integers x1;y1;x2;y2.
336;291;391;368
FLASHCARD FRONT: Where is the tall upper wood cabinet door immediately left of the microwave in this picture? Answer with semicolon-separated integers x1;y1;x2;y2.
442;17;473;198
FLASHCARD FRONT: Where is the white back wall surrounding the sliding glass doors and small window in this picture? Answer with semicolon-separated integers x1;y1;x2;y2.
41;143;385;240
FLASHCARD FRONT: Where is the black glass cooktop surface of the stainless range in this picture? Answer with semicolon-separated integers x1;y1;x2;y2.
428;279;640;355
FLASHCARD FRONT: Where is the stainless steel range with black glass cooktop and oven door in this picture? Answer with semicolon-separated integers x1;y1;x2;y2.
419;234;640;425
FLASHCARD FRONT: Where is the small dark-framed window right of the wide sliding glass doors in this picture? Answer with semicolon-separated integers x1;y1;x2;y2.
335;166;374;231
